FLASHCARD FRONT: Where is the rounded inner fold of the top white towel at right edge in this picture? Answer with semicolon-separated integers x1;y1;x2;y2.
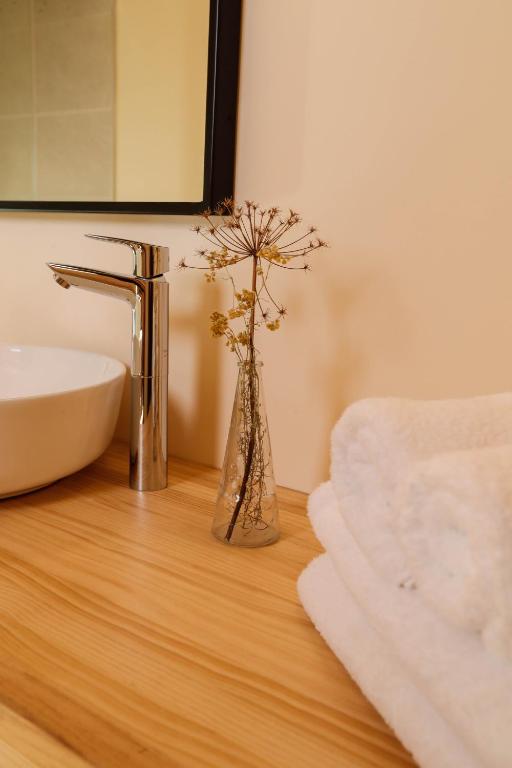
396;445;512;660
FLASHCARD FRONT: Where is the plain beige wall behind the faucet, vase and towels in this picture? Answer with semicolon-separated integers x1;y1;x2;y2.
0;0;512;490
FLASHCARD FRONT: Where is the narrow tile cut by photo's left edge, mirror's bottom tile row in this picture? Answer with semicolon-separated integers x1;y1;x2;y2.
0;117;33;200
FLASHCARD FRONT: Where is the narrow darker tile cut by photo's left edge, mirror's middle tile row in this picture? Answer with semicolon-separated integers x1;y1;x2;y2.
0;26;32;115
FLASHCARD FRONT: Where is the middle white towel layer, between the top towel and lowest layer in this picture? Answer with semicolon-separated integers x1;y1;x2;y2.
309;483;512;768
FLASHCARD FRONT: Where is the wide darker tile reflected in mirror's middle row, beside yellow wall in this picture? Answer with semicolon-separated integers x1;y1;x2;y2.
35;16;114;112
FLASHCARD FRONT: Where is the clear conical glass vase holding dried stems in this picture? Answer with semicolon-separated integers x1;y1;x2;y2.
212;362;279;547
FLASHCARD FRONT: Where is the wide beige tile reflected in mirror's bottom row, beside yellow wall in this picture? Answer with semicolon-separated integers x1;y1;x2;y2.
37;111;113;200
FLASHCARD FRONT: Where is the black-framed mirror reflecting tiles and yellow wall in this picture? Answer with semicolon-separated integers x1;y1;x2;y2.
0;0;241;214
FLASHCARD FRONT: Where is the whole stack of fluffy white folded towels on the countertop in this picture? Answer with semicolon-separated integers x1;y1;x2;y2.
298;394;512;768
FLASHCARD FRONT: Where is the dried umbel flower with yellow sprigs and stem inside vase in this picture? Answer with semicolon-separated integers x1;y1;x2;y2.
184;199;326;541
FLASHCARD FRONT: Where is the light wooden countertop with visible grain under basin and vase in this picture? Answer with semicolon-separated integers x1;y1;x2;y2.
0;445;414;768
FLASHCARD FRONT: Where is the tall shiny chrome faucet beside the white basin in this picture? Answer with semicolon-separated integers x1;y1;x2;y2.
48;235;169;491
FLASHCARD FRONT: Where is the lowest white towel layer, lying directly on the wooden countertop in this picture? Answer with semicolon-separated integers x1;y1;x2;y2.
298;555;481;768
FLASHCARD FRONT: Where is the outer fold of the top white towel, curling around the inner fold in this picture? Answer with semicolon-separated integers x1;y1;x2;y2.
331;393;512;583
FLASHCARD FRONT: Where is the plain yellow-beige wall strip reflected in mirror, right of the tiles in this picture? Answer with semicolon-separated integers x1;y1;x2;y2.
115;0;209;201
